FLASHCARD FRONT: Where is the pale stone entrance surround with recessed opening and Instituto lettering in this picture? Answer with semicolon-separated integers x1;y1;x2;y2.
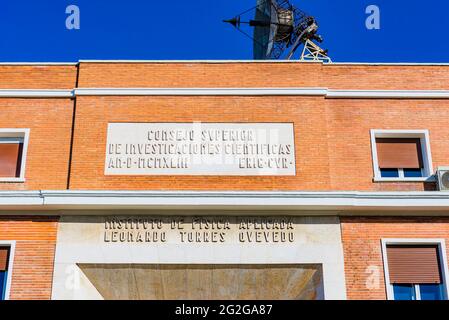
52;215;346;300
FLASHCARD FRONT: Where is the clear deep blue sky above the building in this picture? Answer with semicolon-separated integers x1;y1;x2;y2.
0;0;449;62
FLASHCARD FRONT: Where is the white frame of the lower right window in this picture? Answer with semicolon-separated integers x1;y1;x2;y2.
381;238;449;300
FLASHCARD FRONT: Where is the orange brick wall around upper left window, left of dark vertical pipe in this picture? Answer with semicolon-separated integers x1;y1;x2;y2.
0;98;73;190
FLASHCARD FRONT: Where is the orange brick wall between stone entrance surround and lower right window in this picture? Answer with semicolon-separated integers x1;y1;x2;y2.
341;217;449;300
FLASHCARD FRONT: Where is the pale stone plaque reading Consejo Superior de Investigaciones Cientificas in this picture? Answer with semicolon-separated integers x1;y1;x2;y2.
105;123;296;176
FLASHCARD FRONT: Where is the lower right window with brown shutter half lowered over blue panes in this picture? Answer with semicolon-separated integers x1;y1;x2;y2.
382;240;448;300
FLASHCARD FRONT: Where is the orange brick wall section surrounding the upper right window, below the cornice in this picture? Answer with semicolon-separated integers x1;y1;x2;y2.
324;99;449;191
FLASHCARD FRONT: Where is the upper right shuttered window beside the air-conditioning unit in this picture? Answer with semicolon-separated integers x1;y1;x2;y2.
371;130;433;181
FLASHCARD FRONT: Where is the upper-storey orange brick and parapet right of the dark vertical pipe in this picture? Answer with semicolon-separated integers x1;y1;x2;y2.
70;63;449;191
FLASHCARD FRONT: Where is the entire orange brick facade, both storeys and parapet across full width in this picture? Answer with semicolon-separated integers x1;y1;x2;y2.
0;62;449;299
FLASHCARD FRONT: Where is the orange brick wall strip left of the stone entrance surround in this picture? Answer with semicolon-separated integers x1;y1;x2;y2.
0;216;57;300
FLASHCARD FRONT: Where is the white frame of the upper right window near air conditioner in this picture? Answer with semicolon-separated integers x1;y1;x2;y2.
371;129;435;182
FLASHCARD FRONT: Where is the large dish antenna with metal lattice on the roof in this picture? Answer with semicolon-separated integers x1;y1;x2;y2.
223;0;332;62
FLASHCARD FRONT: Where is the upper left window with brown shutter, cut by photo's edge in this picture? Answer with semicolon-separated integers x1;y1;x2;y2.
0;129;29;182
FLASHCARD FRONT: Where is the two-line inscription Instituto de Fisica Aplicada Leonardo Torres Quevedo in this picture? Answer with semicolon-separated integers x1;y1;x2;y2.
103;217;295;244
